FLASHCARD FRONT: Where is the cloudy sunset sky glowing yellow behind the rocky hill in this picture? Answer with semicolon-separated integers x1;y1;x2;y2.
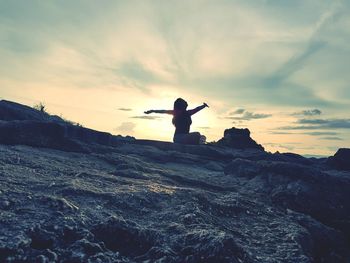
0;0;350;155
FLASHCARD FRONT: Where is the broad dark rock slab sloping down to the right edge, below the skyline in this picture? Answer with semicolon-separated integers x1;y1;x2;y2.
224;159;350;241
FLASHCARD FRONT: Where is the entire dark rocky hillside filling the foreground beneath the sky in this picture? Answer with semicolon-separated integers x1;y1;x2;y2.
0;101;350;263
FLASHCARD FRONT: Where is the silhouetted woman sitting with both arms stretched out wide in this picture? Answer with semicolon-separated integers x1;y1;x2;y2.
145;98;209;144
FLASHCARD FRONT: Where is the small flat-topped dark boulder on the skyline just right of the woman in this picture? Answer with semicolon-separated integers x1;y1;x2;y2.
216;127;264;151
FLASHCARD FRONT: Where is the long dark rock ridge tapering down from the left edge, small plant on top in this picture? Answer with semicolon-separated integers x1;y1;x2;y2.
0;100;133;151
